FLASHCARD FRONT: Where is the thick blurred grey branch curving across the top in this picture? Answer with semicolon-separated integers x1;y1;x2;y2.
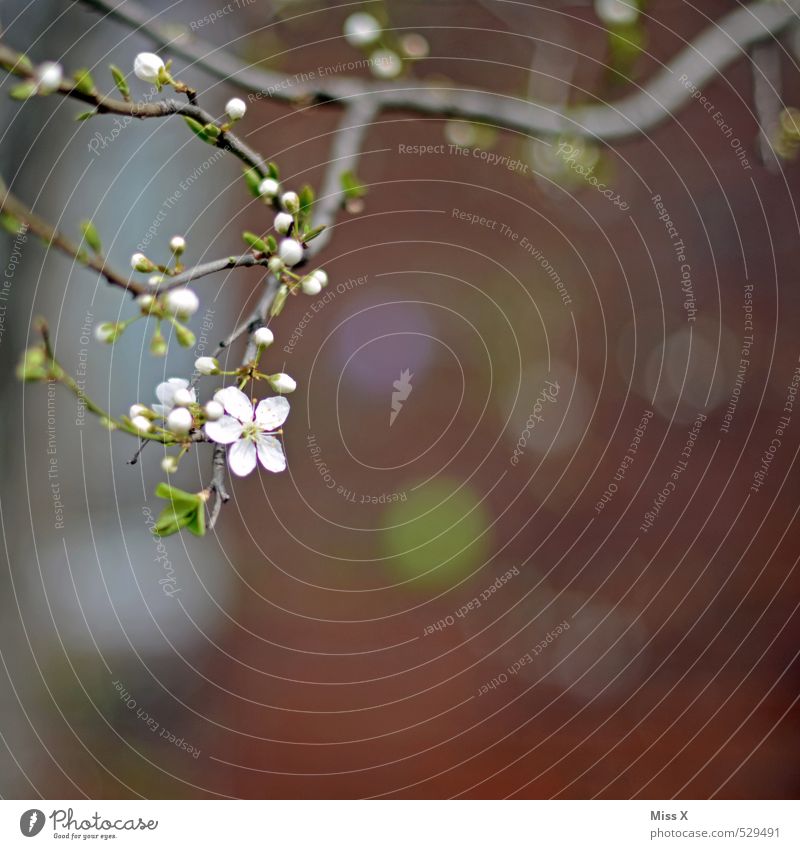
82;0;798;141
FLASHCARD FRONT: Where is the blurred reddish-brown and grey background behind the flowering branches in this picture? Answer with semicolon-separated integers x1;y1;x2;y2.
0;0;800;798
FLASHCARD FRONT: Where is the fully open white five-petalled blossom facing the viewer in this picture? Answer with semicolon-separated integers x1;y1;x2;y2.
204;386;289;477
